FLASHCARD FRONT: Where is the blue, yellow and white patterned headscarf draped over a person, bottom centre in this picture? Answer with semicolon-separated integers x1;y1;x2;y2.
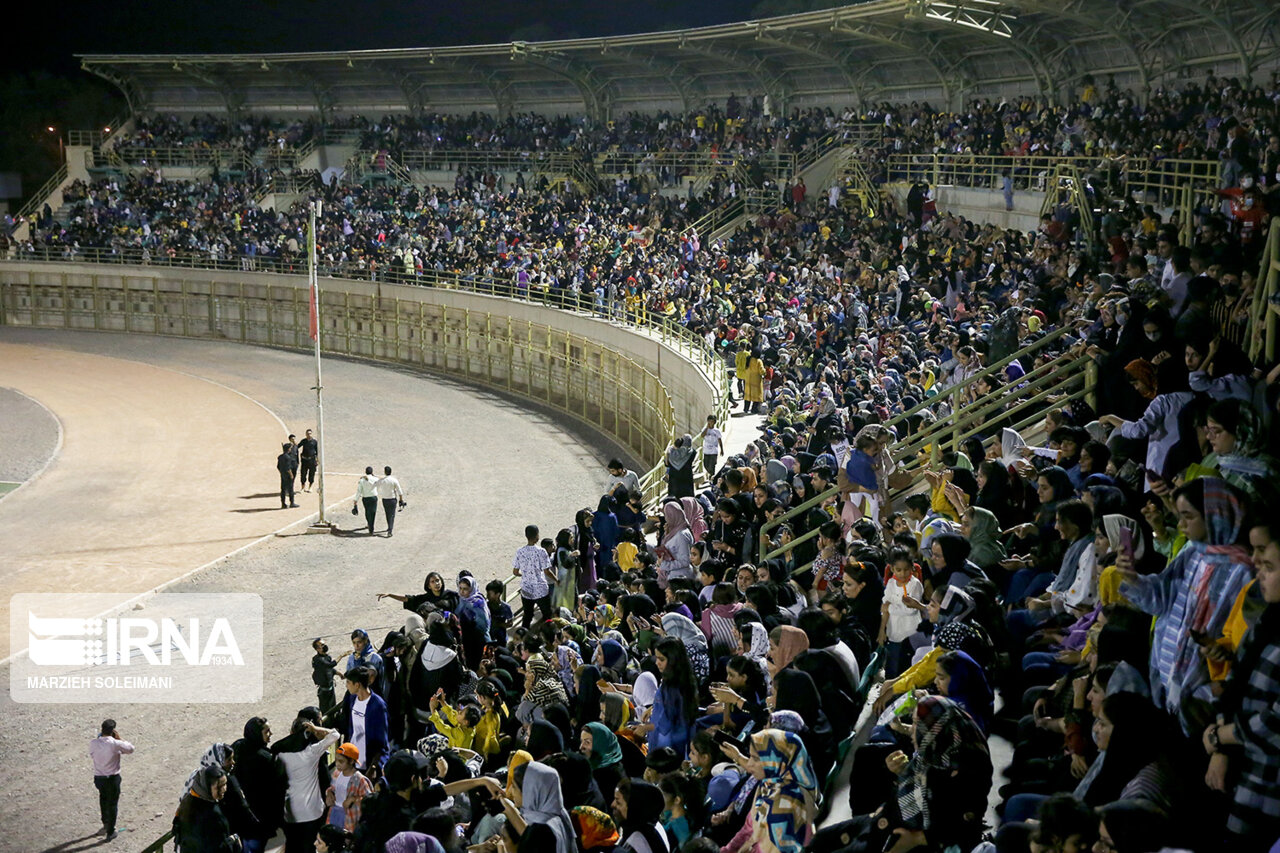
751;729;818;853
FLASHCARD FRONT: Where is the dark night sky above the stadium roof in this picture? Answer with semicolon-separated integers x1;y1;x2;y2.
0;0;768;70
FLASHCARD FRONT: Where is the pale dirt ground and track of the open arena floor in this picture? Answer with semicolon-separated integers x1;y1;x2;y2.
0;329;607;853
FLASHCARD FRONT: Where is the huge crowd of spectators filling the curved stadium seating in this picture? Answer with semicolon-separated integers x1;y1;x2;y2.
10;83;1280;853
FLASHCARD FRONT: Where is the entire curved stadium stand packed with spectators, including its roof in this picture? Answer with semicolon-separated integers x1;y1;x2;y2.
6;0;1280;853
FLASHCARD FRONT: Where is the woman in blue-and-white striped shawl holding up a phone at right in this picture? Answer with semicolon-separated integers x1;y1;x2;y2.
1120;476;1253;733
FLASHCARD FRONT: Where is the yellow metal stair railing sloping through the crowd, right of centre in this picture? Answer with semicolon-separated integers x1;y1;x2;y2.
758;327;1097;575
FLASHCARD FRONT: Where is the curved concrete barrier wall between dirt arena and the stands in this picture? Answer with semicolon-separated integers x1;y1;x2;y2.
0;263;721;465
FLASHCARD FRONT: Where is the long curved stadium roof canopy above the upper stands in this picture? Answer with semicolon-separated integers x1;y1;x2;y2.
81;0;1280;118
